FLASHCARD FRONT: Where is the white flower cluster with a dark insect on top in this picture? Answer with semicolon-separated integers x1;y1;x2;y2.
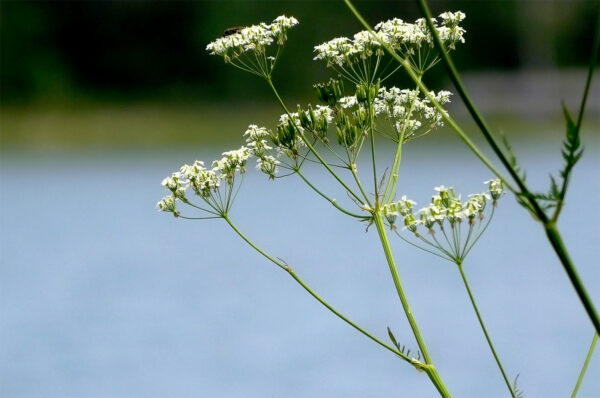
206;15;298;62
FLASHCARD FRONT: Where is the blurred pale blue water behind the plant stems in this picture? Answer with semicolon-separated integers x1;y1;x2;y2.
0;141;600;398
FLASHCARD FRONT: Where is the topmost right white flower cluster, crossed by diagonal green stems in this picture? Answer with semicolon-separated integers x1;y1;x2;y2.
314;11;465;71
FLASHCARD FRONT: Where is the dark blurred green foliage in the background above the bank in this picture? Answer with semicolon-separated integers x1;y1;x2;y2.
0;0;594;105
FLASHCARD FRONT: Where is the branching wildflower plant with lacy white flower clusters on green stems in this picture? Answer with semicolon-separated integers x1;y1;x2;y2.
157;1;596;397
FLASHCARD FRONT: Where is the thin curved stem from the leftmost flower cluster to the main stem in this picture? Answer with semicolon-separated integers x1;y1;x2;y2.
223;215;418;370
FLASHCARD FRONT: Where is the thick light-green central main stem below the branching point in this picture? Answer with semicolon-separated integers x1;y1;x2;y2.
374;213;450;397
